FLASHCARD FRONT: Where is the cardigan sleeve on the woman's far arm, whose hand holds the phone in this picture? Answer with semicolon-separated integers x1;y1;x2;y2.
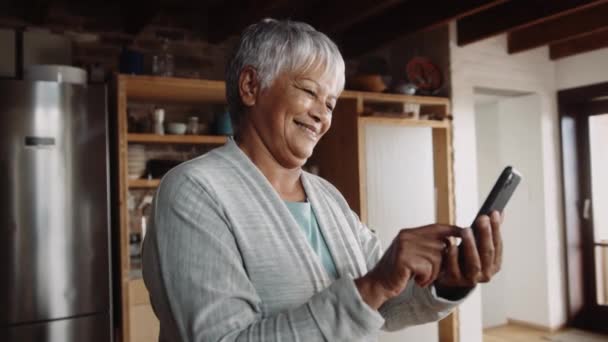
352;212;465;331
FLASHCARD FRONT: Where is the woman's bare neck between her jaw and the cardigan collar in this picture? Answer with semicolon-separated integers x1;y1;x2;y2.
236;128;306;202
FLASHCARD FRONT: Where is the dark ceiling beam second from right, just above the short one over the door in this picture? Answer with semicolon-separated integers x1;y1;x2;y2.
508;1;608;53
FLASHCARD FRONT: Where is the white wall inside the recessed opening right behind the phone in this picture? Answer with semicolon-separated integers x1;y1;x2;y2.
498;95;559;327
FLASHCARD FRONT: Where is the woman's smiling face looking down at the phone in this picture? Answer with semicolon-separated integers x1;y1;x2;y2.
243;68;342;169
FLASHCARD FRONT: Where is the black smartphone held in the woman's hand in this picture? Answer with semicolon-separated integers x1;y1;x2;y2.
459;166;522;264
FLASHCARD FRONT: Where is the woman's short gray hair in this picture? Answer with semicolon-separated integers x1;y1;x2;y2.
226;19;344;132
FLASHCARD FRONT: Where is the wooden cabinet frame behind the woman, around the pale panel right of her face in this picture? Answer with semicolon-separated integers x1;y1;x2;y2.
313;91;458;341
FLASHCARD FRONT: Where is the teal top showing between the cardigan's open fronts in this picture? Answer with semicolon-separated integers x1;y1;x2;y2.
285;201;338;279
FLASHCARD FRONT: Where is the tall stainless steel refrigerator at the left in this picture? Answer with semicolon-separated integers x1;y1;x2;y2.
0;81;112;342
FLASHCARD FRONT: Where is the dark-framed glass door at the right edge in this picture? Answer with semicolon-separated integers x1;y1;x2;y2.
558;83;608;332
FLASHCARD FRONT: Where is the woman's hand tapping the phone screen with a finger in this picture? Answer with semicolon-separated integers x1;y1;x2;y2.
355;224;462;309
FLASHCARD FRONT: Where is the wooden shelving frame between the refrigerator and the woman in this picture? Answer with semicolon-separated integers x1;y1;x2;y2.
111;75;228;342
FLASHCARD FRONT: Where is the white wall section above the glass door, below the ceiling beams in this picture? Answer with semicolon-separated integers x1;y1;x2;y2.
556;48;608;89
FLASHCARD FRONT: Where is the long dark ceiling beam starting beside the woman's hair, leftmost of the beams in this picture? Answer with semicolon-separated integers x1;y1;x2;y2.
341;0;507;57
